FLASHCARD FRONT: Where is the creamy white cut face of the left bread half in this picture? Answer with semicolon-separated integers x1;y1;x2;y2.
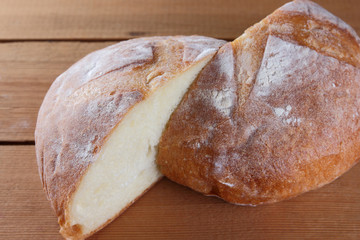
66;55;212;236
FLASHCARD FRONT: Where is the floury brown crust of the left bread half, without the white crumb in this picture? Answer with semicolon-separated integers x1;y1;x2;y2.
35;36;225;239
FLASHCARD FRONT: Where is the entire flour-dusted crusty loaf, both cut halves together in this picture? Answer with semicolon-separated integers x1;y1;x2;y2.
35;1;360;239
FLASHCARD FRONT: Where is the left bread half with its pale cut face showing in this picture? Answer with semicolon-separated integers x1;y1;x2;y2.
35;36;224;239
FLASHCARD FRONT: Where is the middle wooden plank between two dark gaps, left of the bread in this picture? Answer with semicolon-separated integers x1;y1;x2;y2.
0;42;114;141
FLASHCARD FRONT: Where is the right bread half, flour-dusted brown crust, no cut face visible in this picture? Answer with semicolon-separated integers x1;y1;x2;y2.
157;1;360;205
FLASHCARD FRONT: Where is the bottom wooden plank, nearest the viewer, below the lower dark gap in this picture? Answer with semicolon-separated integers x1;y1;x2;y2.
0;146;360;239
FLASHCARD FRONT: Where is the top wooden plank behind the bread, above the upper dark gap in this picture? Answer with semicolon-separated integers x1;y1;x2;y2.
0;0;360;40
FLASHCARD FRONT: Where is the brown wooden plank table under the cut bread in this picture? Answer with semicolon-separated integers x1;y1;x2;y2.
0;0;360;239
